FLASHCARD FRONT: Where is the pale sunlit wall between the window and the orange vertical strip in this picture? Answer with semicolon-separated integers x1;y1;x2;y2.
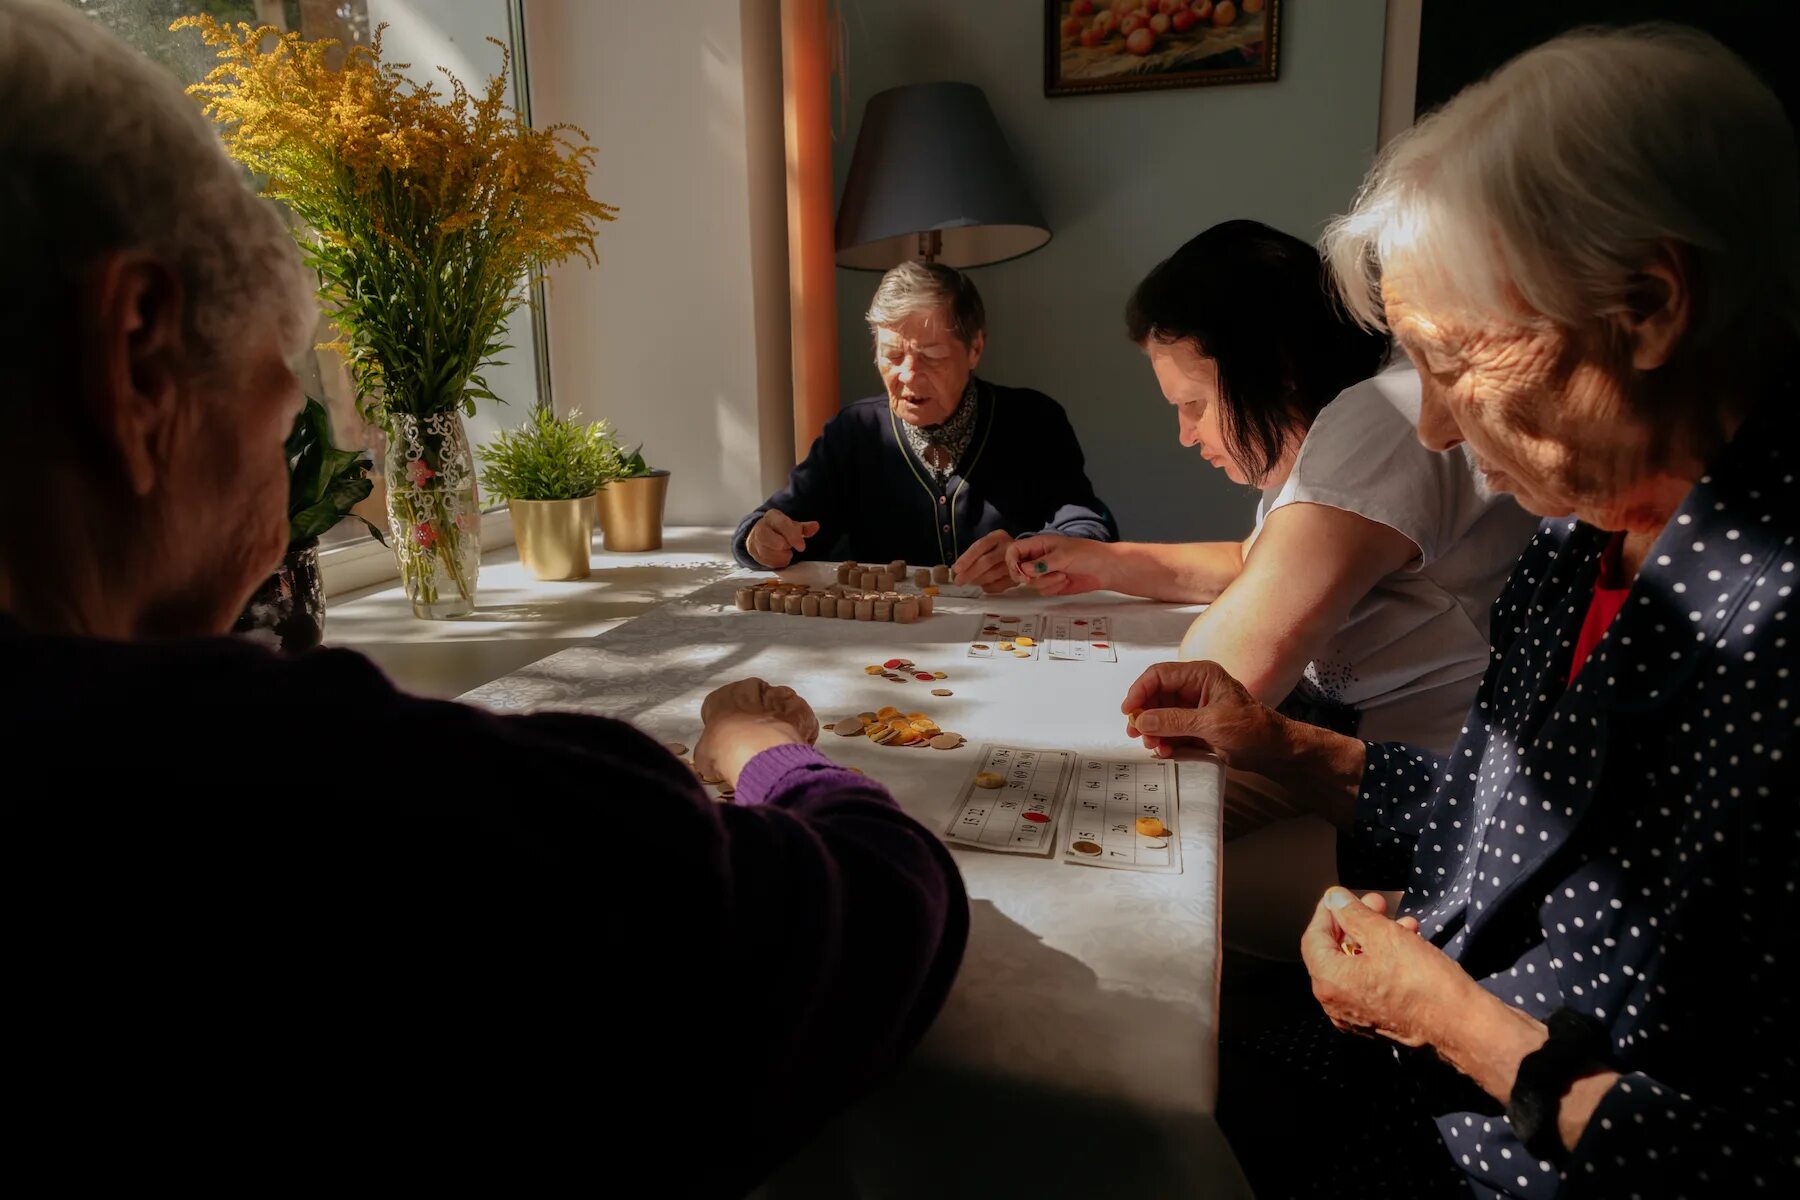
526;0;792;524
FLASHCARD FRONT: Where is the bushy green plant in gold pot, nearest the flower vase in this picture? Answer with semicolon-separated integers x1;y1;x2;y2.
481;408;619;579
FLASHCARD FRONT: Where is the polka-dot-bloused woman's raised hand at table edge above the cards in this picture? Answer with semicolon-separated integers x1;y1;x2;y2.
1120;662;1287;770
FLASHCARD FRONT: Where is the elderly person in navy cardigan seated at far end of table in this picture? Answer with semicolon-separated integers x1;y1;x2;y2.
733;263;1120;592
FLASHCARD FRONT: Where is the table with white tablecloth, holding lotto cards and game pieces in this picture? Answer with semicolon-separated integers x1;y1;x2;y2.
464;563;1249;1198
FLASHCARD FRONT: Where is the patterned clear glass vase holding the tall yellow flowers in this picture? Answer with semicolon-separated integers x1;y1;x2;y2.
385;412;481;621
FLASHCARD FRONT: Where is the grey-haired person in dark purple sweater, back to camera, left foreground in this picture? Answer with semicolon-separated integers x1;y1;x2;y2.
0;0;968;1195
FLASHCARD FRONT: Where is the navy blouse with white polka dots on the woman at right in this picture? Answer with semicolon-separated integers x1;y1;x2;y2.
1339;408;1800;1196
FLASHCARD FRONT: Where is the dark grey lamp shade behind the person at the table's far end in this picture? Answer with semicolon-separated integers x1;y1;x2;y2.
837;83;1049;270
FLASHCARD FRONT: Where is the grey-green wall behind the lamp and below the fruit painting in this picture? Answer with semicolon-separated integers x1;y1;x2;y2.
837;0;1384;540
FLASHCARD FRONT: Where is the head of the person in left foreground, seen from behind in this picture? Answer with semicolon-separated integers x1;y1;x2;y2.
0;0;313;631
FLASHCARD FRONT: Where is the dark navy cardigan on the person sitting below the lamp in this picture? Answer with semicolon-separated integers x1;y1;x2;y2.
731;380;1120;569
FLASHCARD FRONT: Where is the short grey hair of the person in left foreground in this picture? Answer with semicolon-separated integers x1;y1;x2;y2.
0;0;317;369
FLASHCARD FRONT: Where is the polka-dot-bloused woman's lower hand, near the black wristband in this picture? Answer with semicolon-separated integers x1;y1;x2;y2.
1300;887;1468;1045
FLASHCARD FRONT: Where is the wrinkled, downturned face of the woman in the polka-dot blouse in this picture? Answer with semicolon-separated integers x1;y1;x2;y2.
1382;257;1651;529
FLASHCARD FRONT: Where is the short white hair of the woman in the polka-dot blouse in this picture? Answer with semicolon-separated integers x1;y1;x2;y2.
1321;25;1800;347
